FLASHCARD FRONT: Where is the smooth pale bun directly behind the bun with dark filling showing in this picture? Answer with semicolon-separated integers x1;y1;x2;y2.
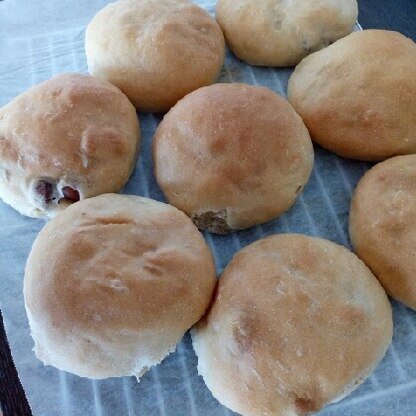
85;0;225;112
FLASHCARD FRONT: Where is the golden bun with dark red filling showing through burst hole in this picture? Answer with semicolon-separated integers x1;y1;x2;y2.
0;74;140;218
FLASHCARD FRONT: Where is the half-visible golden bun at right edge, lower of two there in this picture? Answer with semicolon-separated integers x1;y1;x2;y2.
350;155;416;310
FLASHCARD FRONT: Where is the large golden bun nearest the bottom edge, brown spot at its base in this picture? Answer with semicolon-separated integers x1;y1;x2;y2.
192;234;393;416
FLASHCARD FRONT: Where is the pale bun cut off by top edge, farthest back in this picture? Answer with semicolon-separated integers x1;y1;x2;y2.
216;0;358;66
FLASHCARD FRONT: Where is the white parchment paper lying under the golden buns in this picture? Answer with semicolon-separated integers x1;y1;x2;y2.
0;0;416;416
